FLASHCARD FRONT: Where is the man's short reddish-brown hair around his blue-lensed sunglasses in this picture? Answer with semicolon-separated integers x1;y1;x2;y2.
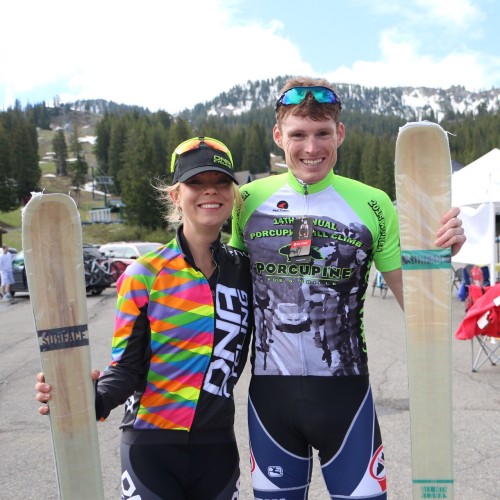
276;76;340;126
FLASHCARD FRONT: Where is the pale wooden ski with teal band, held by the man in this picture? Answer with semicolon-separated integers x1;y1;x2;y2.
395;122;454;499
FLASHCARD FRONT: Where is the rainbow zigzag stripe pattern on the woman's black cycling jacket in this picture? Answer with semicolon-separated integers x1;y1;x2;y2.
111;240;215;431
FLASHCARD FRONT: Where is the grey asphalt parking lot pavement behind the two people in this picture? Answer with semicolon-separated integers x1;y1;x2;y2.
0;288;500;500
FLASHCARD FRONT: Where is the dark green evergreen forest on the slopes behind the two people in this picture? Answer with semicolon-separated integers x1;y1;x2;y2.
0;97;500;229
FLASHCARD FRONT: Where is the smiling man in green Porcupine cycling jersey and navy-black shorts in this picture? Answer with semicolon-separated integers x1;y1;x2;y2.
230;78;465;500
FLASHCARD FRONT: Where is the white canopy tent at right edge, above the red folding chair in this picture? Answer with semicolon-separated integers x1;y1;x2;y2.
451;148;500;283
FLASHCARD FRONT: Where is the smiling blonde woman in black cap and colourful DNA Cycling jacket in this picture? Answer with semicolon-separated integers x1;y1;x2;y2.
36;137;252;500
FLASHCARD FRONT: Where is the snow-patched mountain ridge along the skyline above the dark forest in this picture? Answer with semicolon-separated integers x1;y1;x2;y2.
64;76;500;122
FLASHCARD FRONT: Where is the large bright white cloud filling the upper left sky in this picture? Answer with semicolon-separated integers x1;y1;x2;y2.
0;0;311;112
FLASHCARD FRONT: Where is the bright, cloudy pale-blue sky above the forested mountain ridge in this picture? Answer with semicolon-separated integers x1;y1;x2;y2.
0;0;500;113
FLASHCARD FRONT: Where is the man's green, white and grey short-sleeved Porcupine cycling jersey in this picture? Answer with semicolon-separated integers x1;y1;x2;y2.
230;171;401;376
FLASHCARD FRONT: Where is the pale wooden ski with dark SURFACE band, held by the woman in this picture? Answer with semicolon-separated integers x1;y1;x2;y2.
22;194;104;500
